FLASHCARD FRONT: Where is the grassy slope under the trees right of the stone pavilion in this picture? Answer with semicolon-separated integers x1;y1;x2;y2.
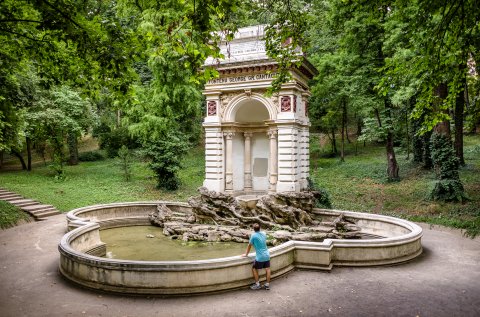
311;136;480;235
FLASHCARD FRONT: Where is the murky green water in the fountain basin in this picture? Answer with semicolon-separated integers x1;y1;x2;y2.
100;226;247;261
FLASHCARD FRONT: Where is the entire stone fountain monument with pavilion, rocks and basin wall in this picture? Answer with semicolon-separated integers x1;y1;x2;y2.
59;26;422;295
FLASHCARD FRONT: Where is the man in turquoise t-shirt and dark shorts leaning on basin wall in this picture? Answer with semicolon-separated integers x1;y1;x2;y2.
242;223;270;290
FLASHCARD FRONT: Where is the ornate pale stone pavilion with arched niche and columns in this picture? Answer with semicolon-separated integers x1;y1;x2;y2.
203;26;316;194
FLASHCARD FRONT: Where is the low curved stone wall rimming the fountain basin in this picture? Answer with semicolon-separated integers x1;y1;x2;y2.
59;201;422;295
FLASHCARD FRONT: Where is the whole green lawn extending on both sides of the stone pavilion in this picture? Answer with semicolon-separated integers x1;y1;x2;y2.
0;136;480;235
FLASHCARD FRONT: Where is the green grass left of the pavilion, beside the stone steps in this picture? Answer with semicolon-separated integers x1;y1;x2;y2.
0;149;204;211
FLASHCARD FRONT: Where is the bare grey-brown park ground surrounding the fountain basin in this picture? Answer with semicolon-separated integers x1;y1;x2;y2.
0;215;480;317
